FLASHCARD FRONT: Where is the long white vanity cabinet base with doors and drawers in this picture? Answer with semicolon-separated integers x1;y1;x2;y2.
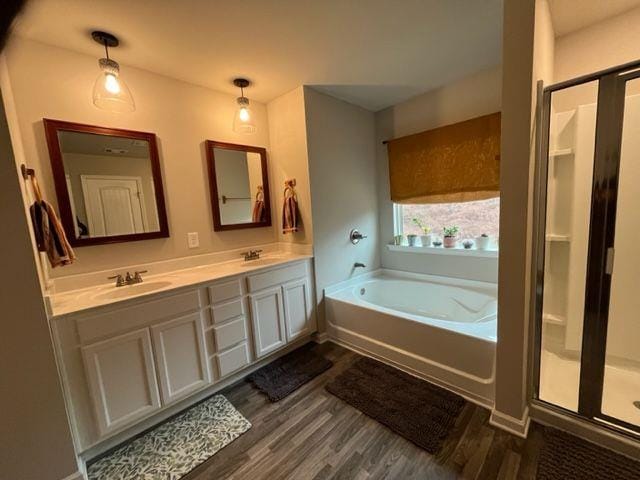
51;259;316;452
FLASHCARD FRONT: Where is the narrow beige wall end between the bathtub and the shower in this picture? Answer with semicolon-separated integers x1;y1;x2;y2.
495;0;540;428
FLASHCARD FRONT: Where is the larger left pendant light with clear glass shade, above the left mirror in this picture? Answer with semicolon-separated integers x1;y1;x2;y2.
91;31;136;113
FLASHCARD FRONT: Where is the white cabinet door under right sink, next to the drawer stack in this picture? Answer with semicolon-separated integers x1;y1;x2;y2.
249;287;287;358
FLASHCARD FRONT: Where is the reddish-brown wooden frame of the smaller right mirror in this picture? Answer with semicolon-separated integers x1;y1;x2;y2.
205;140;271;232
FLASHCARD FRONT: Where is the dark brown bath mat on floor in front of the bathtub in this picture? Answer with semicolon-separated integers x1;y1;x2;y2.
326;357;465;454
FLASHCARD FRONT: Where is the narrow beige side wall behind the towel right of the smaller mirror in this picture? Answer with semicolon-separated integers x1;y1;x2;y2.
267;87;313;244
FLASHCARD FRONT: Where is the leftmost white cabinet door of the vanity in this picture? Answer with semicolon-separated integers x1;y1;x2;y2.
82;328;160;436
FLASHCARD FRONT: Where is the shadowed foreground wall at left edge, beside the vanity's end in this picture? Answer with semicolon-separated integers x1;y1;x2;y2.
0;89;77;480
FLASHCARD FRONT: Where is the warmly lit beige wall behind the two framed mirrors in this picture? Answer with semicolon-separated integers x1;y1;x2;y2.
6;37;280;276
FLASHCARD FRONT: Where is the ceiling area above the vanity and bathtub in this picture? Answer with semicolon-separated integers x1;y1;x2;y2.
16;0;502;111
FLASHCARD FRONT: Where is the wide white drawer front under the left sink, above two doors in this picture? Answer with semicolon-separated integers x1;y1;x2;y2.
76;287;202;344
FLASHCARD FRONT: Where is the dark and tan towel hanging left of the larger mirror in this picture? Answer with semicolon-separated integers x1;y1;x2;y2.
30;200;76;268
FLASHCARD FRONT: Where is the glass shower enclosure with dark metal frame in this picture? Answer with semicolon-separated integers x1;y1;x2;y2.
534;62;640;437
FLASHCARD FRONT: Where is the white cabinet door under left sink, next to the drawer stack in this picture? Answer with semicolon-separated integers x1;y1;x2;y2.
151;312;209;405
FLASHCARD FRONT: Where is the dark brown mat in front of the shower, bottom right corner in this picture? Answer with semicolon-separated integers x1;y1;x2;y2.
536;428;640;480
